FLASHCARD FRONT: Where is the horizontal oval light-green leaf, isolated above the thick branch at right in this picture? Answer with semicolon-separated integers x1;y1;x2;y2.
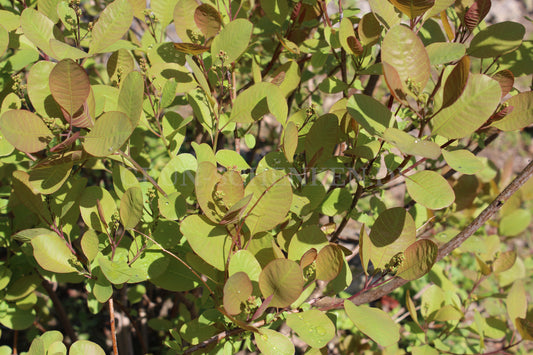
405;171;455;210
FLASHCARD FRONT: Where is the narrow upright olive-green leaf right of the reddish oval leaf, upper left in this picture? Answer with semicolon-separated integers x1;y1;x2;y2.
117;71;144;128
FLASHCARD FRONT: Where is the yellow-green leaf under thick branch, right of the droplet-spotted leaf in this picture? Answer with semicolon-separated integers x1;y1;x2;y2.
344;300;400;347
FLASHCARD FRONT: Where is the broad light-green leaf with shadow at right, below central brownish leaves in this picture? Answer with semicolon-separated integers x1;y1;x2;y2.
180;215;231;271
